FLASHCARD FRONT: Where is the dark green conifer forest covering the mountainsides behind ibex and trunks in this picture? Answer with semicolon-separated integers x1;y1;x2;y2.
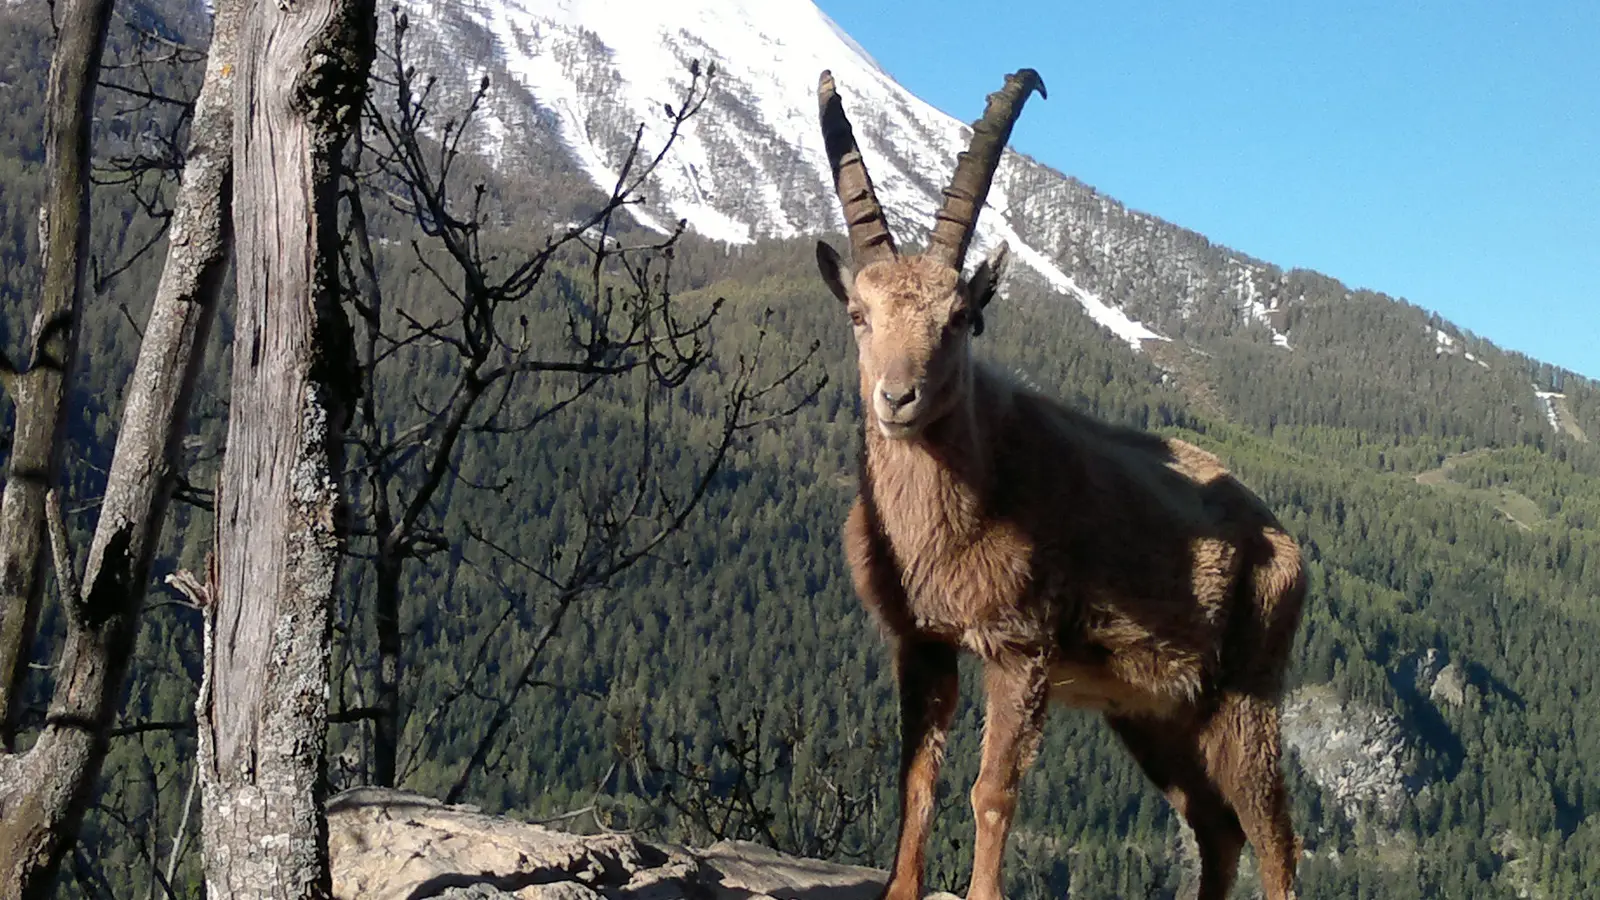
0;1;1600;900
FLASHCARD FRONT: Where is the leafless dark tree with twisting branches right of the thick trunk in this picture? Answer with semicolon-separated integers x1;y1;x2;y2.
341;11;816;799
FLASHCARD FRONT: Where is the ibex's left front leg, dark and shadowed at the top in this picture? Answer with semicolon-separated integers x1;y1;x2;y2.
883;637;960;900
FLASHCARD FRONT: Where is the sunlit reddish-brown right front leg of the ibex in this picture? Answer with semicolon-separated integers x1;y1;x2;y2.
966;657;1050;900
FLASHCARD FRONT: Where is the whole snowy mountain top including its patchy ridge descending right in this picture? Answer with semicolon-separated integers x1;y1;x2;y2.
384;0;1574;438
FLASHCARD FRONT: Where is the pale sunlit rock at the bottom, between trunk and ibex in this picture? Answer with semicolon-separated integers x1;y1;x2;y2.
328;788;885;900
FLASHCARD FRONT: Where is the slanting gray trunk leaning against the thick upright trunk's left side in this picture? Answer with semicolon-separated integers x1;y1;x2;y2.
0;0;237;898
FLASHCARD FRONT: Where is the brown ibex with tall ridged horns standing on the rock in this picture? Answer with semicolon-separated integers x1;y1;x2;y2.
816;69;1306;900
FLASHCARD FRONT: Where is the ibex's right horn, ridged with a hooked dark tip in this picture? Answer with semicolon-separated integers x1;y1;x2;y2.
928;69;1050;271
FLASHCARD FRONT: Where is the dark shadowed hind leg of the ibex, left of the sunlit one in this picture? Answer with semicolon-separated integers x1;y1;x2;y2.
1106;717;1245;900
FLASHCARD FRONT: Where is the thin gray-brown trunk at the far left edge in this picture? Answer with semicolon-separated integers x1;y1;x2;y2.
0;0;112;751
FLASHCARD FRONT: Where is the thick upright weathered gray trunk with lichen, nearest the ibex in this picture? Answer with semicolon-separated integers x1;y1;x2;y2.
197;0;374;898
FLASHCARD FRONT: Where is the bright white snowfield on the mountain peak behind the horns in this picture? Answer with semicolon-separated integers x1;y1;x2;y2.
395;0;1184;346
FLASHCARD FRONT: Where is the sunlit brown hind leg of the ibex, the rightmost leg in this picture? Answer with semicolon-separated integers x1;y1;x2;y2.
1200;693;1299;900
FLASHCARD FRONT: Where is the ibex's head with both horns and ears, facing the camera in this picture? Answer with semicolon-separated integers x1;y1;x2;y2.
816;69;1045;439
